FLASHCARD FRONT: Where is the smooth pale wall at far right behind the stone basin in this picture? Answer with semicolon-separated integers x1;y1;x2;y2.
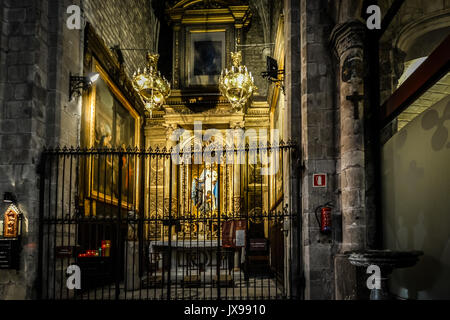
382;96;450;299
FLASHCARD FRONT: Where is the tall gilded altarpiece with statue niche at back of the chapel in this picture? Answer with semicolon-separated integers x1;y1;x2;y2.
144;0;269;241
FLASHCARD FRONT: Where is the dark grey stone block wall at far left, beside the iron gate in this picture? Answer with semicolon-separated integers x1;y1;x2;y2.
0;0;50;299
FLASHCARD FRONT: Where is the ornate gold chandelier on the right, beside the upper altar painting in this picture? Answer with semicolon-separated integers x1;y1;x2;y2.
219;51;258;111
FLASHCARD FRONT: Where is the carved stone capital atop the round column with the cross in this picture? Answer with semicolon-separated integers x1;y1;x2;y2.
330;20;366;60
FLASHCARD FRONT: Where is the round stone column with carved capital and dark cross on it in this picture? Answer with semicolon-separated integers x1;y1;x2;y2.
332;21;366;252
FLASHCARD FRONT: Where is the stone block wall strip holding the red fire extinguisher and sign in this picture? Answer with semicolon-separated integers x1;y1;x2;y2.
300;0;340;299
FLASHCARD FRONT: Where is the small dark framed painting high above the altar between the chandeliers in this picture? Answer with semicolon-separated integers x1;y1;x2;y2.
187;29;226;86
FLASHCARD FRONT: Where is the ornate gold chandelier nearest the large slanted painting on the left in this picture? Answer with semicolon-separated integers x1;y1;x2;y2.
133;53;170;113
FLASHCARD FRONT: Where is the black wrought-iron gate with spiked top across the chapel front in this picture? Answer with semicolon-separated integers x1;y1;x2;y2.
39;143;300;300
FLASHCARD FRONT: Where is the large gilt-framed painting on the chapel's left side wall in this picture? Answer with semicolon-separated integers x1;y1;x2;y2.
86;59;140;210
